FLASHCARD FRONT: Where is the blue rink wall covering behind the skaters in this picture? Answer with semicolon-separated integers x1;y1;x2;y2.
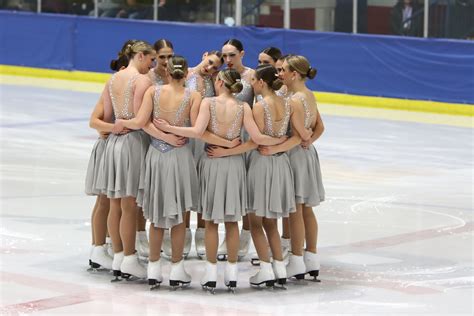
0;12;474;104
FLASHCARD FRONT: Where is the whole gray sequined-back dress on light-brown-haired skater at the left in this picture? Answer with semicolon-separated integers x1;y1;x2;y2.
97;74;150;198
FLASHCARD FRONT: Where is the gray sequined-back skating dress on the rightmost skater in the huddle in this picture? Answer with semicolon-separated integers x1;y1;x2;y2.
289;98;325;207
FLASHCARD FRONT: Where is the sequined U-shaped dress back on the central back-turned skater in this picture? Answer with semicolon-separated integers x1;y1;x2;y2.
209;98;244;140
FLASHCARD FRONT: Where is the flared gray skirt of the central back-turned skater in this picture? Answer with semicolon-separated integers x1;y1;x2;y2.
198;155;247;224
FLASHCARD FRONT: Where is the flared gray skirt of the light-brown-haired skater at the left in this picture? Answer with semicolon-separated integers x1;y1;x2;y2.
97;130;150;198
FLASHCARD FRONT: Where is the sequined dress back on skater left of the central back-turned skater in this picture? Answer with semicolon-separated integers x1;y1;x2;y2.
151;85;191;153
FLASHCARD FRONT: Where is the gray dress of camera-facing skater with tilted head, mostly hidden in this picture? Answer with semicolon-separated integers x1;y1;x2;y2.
186;71;216;164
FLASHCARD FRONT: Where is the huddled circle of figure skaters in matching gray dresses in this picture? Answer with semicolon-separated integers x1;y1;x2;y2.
86;39;324;292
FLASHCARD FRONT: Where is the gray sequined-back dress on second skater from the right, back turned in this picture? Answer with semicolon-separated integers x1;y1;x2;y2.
247;100;296;218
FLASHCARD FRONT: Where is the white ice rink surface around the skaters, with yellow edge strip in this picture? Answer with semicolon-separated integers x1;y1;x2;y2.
0;76;474;316
